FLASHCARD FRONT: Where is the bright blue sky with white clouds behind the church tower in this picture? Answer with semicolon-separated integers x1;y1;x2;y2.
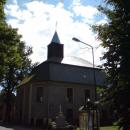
5;0;107;65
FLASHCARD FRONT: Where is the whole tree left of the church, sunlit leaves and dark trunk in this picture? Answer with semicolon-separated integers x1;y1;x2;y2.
0;0;33;120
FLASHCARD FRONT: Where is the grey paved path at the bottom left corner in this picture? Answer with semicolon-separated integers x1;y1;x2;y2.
0;126;42;130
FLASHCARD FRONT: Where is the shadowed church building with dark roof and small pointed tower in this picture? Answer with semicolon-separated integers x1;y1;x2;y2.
17;31;105;125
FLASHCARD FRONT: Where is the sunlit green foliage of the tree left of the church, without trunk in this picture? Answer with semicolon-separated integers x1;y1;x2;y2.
0;25;32;91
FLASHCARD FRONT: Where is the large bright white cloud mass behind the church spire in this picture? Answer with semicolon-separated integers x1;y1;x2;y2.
5;0;104;64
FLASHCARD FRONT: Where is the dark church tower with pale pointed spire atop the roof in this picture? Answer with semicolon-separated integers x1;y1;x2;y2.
47;31;64;63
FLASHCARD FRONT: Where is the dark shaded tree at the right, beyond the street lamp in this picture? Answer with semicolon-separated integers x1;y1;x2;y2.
93;0;130;130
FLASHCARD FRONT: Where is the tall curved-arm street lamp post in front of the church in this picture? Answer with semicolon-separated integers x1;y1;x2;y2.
72;37;99;130
